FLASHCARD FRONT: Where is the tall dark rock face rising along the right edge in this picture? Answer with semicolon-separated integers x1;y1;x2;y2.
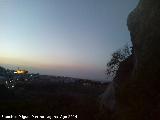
100;0;160;120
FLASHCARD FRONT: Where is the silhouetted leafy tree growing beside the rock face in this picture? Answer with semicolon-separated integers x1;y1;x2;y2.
105;44;131;80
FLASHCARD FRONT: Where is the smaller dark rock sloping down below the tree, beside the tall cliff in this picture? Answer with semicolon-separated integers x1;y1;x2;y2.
100;55;134;118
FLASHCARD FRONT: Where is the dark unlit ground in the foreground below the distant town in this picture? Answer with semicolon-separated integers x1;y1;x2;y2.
0;81;107;120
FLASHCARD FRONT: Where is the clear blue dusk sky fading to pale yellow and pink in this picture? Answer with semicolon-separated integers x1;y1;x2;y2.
0;0;138;80
